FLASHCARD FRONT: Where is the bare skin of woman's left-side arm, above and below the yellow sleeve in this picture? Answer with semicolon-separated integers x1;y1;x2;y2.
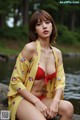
18;42;39;104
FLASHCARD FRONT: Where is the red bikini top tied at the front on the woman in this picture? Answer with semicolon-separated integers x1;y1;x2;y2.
35;67;56;84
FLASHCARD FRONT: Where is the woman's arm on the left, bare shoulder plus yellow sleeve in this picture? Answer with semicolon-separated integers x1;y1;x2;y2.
8;43;34;96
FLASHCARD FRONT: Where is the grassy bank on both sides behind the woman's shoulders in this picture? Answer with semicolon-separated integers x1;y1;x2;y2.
0;39;80;56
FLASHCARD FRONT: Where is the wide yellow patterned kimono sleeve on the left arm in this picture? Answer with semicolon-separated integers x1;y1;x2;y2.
10;53;30;91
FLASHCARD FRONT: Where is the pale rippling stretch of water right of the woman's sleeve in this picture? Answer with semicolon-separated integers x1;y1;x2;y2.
65;74;80;99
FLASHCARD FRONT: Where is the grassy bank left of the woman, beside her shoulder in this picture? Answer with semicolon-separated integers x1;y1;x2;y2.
0;40;26;55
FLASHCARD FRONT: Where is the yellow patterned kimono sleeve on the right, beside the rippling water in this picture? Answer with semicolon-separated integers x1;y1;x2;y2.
55;63;65;90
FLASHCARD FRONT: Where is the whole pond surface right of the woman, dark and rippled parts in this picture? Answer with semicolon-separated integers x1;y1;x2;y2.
63;57;80;115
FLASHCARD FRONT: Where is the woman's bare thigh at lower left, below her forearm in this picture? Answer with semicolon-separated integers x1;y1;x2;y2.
17;99;46;120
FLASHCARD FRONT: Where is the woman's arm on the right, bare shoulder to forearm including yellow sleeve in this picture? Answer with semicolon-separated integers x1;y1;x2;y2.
54;49;65;102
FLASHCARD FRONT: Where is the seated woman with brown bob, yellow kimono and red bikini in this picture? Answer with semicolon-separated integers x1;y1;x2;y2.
8;10;73;120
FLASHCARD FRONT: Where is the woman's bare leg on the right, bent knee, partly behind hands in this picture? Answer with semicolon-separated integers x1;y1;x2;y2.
42;98;73;120
